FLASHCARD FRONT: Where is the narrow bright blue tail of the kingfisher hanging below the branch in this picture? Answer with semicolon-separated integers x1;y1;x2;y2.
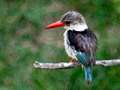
84;66;92;84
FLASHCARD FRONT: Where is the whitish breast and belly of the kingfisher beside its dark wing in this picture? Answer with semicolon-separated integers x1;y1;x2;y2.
64;30;77;60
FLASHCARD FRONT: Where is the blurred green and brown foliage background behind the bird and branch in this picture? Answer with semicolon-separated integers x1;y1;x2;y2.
0;0;120;90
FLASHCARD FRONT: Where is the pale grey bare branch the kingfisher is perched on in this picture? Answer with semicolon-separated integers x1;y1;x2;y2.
33;59;120;69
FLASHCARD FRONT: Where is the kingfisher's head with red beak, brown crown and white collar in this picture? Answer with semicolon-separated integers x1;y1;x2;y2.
45;11;87;31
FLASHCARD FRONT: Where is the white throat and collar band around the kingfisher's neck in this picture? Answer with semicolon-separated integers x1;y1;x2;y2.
64;24;88;31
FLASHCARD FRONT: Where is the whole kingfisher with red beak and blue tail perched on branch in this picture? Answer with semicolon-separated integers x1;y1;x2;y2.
45;11;97;84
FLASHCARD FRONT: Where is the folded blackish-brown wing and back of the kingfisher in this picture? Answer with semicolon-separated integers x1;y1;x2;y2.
68;29;97;64
